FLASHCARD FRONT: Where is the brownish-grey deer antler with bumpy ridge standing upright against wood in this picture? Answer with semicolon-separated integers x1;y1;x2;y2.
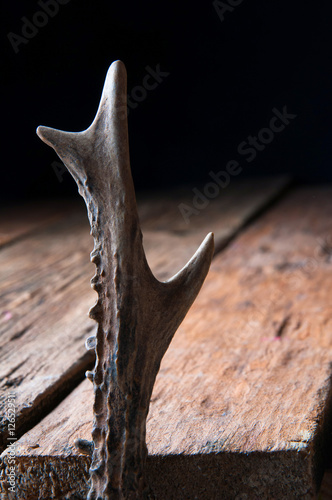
37;61;214;500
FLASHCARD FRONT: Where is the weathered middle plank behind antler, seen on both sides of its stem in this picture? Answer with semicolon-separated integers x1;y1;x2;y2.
0;179;288;458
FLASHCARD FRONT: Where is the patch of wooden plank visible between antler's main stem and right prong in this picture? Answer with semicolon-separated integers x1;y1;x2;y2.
139;177;290;280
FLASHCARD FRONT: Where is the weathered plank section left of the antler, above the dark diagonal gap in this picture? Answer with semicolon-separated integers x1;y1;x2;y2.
0;209;95;447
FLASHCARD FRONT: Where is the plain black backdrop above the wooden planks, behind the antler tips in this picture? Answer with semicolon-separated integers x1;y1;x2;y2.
1;0;332;201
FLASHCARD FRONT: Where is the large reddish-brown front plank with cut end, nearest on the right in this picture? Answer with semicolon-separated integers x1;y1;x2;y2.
3;187;332;500
